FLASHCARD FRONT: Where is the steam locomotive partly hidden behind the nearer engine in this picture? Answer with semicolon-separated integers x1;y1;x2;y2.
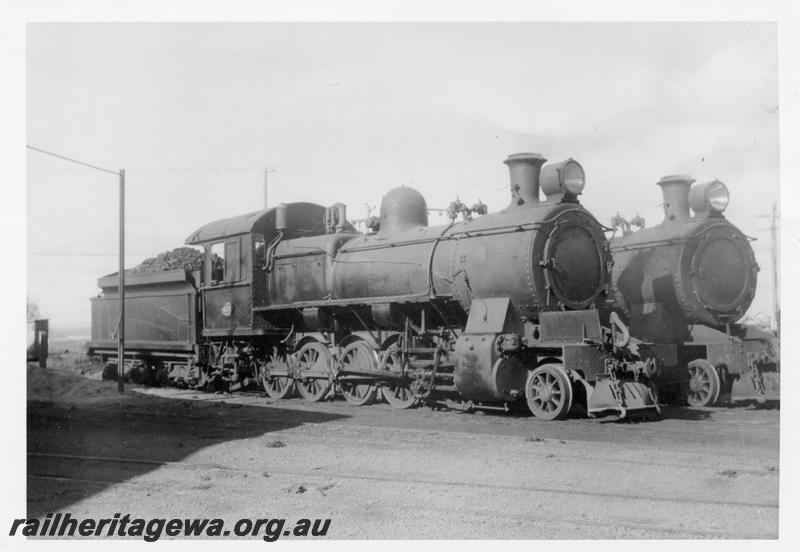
606;175;780;406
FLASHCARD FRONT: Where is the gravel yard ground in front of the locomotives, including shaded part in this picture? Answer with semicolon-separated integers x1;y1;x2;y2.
28;358;779;539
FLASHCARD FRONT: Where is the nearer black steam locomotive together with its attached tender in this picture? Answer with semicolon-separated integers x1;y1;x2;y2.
89;153;658;419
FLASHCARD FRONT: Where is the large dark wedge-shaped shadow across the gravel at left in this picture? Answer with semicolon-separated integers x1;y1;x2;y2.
27;371;347;518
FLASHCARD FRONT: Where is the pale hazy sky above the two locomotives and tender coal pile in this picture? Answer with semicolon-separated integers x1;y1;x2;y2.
25;22;780;327
